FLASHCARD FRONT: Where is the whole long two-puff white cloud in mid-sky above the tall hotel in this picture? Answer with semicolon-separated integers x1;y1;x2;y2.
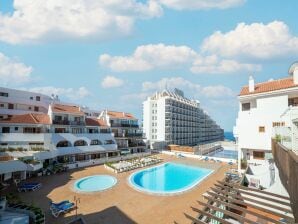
99;44;261;74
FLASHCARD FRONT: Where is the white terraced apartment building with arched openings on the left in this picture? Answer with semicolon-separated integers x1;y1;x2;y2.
0;88;120;181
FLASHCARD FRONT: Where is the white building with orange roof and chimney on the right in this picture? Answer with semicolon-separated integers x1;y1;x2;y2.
233;63;298;166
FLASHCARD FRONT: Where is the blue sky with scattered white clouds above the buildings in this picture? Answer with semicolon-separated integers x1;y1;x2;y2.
0;0;298;131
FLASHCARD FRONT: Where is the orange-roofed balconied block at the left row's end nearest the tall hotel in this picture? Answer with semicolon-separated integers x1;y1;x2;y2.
99;110;148;154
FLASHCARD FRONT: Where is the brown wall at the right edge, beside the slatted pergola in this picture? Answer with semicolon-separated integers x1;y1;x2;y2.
272;139;298;222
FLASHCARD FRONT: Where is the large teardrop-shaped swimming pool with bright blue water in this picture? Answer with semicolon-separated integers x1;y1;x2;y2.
129;163;213;194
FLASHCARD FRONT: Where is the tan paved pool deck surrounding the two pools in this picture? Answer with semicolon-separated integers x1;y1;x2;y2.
4;155;230;224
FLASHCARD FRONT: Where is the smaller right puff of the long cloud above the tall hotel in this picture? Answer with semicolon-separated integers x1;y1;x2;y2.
191;55;261;74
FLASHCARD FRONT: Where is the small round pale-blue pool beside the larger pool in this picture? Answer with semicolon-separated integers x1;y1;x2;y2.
74;175;117;192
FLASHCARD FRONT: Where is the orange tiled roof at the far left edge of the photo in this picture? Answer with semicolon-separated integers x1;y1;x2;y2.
0;113;51;124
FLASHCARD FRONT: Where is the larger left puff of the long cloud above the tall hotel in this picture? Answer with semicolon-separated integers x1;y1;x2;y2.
99;44;197;72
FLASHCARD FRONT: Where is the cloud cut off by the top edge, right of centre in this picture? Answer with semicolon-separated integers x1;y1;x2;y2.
160;0;245;10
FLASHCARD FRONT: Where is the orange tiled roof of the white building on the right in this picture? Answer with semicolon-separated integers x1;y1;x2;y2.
239;77;298;96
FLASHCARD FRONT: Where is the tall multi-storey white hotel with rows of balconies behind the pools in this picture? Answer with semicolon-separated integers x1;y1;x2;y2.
143;89;224;149
